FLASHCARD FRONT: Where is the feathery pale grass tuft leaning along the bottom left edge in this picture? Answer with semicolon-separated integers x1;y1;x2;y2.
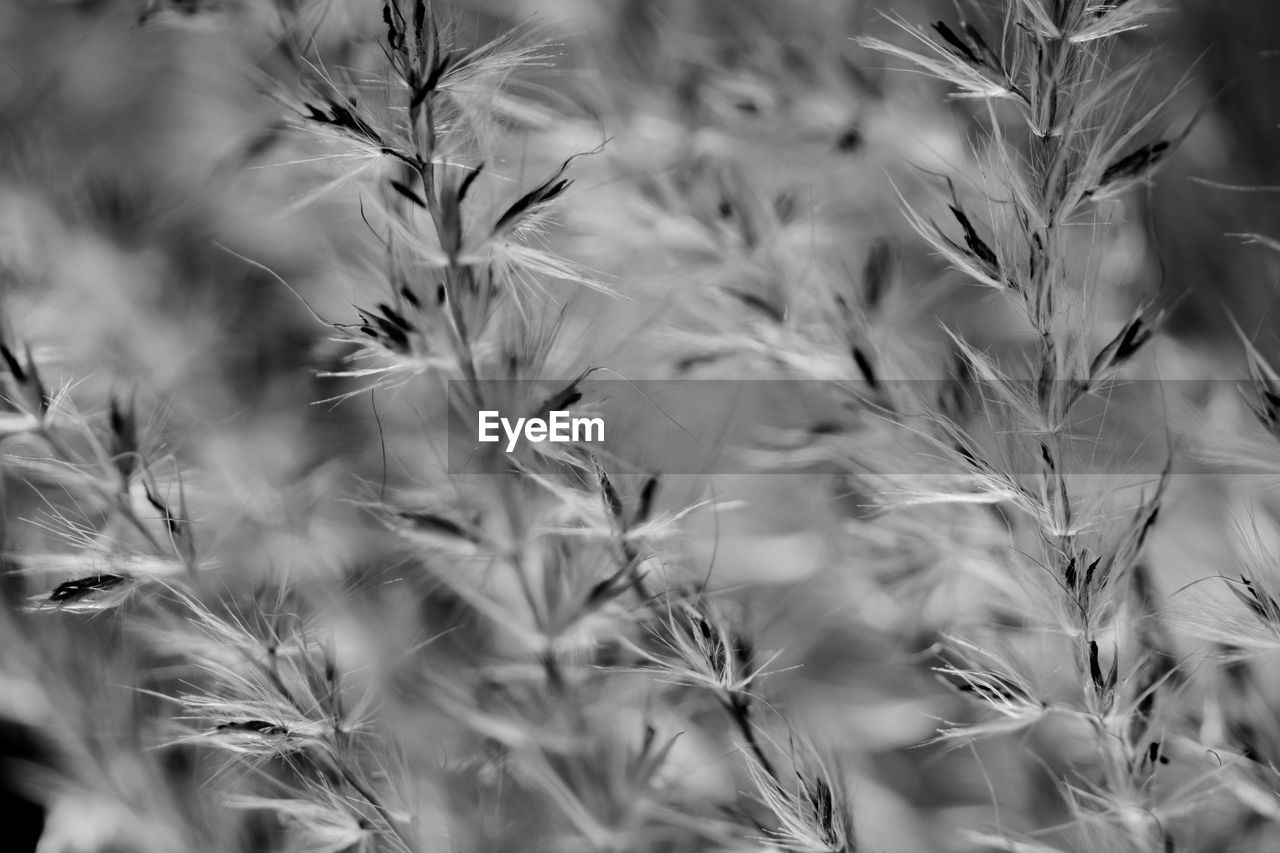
154;589;417;850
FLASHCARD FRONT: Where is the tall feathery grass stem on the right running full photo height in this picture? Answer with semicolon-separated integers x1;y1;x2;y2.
861;0;1203;849
